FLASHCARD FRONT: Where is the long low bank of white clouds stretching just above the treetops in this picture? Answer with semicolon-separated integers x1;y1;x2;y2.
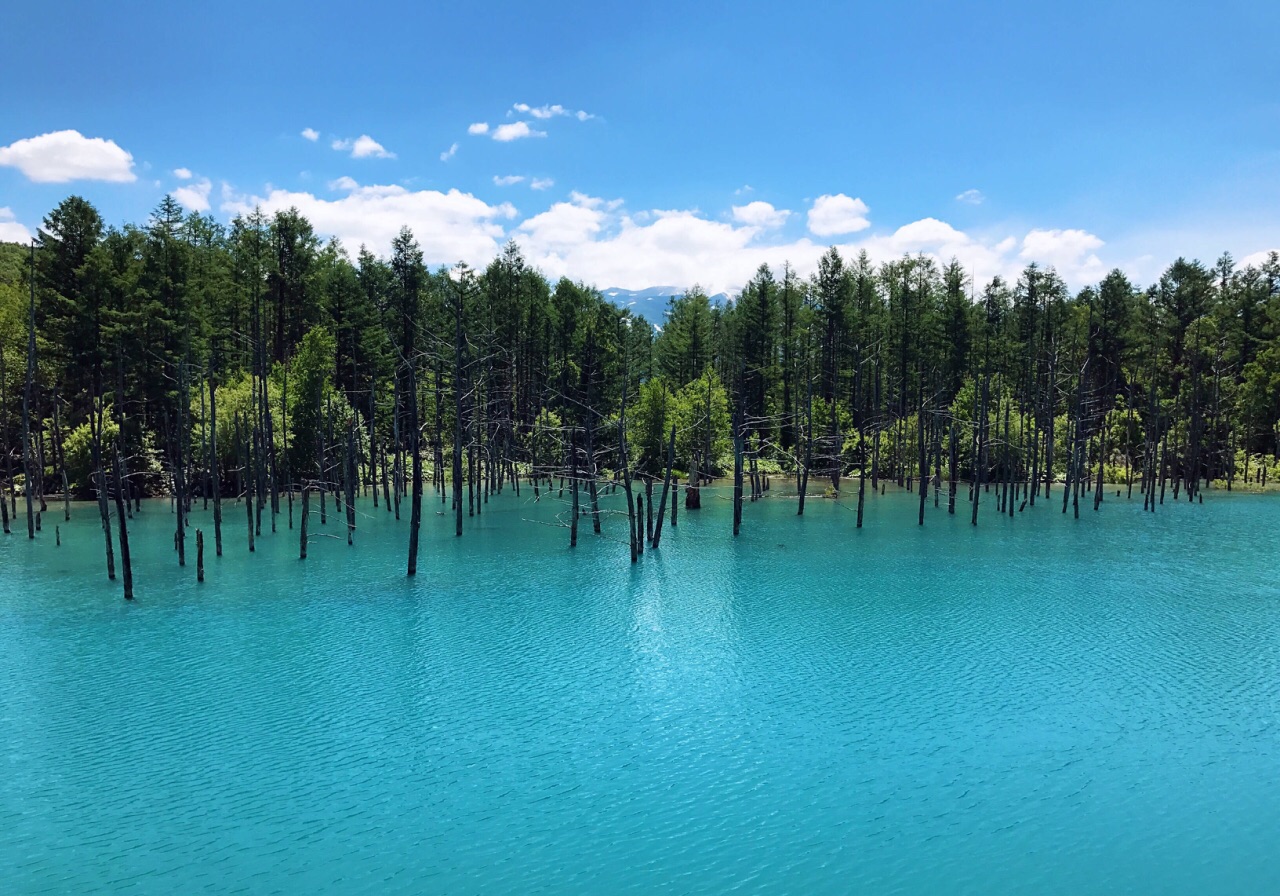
209;174;1105;292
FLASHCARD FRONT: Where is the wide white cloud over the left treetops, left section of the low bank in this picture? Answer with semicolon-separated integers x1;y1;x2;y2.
221;184;516;268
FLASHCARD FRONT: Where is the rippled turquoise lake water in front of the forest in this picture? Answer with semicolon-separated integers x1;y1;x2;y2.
0;489;1280;893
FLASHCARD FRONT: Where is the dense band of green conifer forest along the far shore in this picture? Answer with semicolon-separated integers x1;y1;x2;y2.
0;196;1280;560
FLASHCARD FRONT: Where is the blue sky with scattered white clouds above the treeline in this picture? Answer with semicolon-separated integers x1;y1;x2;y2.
0;0;1280;289
